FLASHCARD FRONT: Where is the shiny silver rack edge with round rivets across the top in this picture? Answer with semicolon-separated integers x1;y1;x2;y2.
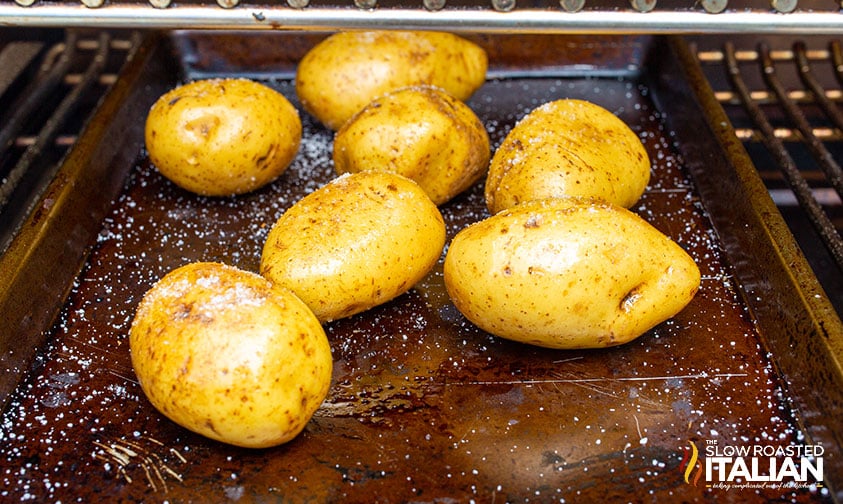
0;0;843;35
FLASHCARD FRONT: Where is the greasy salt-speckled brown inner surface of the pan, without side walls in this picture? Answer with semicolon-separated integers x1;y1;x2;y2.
0;34;828;502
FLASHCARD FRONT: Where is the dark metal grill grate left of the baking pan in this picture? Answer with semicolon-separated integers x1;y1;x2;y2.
0;31;142;253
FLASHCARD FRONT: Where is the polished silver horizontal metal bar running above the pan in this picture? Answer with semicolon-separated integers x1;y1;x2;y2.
0;6;843;35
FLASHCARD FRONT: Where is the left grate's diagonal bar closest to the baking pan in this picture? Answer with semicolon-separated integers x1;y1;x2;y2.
0;31;109;215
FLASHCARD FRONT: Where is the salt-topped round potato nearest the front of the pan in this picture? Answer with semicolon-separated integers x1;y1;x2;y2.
129;262;333;448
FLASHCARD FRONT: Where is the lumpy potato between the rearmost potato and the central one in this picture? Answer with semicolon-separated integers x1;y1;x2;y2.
334;86;490;205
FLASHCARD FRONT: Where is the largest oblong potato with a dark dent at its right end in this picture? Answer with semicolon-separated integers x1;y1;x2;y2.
444;198;700;349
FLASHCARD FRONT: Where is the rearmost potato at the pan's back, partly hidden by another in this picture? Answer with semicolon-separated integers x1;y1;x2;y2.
296;31;488;131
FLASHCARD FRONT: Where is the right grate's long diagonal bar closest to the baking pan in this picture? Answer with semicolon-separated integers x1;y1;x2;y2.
725;42;843;268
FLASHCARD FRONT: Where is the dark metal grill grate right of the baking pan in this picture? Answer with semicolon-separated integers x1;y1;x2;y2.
695;37;843;312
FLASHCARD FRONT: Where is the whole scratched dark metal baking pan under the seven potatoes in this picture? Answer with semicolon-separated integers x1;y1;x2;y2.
0;32;843;503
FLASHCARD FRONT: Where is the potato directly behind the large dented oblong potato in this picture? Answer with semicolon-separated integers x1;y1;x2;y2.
486;99;650;213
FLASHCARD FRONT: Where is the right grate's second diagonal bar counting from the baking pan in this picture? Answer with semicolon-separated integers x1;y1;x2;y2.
759;44;843;201
